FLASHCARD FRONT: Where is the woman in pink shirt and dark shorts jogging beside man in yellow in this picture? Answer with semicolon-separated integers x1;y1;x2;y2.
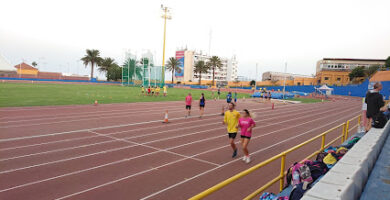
238;109;256;163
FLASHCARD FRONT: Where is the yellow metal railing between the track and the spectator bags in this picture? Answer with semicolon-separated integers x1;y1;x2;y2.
190;115;361;200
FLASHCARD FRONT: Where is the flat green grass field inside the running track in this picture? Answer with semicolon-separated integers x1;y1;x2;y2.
0;83;250;107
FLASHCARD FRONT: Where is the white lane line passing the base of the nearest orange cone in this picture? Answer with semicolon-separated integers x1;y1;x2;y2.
0;101;298;142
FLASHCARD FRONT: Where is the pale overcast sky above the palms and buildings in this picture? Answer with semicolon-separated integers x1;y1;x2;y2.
0;0;390;78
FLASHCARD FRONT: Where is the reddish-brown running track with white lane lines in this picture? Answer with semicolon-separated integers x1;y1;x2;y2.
0;99;361;200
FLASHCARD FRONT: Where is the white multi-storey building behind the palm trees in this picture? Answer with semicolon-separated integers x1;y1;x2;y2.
175;50;238;84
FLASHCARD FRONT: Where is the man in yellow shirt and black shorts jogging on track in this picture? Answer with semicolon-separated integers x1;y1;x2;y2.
222;103;240;158
